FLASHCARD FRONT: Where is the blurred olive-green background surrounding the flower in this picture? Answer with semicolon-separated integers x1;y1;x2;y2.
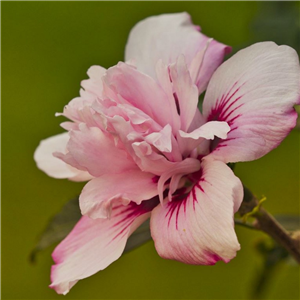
1;1;300;299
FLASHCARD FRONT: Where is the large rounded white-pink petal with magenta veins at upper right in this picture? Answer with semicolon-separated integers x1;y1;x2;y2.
203;42;300;162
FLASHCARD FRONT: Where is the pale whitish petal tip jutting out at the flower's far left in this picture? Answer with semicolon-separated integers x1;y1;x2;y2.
34;132;93;181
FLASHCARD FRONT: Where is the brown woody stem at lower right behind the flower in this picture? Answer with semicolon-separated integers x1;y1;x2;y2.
239;187;300;264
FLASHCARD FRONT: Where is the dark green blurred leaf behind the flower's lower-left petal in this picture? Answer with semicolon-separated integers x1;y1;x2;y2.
29;197;81;263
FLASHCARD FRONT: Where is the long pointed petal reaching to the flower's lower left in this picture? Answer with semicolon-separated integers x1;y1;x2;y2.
50;198;158;295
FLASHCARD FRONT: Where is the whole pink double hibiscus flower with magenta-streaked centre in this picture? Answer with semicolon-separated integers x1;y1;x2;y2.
35;13;300;294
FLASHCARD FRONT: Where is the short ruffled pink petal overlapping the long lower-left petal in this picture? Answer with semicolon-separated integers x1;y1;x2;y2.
79;170;158;219
